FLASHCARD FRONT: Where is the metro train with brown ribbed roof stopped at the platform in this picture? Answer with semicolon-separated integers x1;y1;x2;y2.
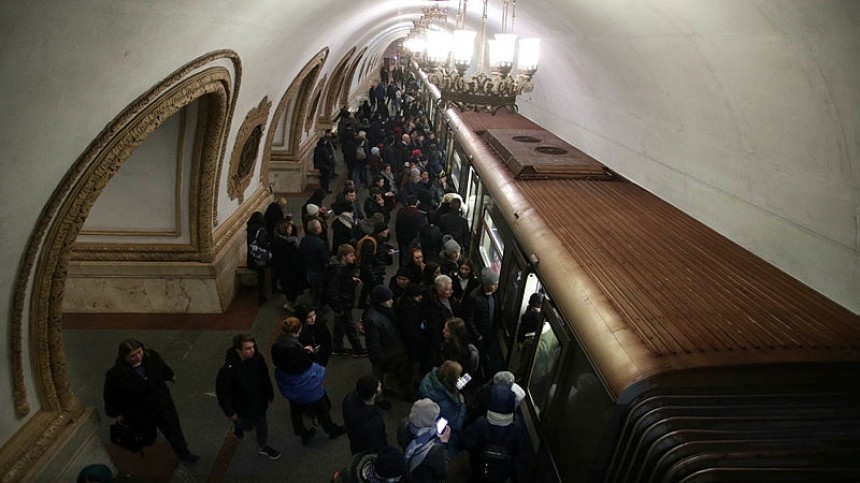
414;79;860;483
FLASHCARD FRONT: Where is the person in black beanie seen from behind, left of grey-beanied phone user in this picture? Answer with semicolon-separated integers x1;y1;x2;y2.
343;375;388;454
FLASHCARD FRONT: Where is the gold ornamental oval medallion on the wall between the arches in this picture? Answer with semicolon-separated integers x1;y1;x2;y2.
227;96;272;203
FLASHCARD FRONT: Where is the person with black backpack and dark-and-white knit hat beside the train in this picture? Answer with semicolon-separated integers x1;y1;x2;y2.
460;384;527;482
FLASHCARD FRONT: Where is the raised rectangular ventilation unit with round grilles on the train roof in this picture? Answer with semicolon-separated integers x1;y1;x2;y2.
483;129;613;179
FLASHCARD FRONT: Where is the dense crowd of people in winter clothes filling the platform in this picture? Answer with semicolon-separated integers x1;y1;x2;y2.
105;65;525;481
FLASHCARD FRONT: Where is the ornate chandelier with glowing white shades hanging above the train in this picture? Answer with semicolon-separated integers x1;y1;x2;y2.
403;0;540;113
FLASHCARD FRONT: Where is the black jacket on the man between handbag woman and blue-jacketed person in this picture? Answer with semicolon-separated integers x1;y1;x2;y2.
215;347;275;419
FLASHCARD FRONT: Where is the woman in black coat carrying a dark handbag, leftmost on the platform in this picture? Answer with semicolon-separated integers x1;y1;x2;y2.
104;338;200;463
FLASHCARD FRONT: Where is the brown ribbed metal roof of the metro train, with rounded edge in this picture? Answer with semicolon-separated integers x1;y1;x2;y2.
450;108;860;396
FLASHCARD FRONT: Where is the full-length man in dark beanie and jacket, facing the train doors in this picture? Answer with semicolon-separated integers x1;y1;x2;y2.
362;285;409;409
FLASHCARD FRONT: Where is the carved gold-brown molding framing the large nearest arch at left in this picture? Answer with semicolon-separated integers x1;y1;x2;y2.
0;50;241;481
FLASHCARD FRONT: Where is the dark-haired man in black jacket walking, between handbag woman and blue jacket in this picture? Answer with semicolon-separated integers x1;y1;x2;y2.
215;334;281;460
